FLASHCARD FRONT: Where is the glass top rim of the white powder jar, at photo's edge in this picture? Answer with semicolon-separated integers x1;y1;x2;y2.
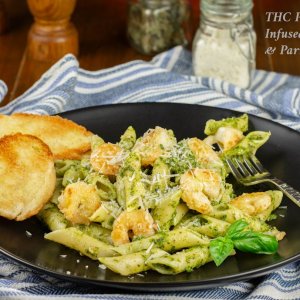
200;0;253;16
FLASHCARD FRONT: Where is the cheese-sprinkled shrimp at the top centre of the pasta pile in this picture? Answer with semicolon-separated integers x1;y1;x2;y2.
133;126;176;166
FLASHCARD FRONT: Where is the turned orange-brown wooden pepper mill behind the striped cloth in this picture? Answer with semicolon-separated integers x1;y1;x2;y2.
27;0;78;62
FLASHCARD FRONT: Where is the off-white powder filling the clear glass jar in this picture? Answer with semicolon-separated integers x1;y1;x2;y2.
193;29;251;88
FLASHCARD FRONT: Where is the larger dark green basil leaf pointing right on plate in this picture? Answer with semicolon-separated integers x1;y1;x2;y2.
231;231;278;254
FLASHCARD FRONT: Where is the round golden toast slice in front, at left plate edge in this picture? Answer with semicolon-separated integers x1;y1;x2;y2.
0;133;56;221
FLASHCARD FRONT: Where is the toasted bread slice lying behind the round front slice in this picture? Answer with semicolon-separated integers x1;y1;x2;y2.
0;113;92;159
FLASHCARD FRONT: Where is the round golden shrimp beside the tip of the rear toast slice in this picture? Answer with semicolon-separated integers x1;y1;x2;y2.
91;143;124;175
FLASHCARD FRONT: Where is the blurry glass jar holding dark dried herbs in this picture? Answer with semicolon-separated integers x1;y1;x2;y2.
127;0;191;54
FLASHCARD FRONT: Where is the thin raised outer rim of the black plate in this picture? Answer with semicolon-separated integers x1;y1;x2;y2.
0;102;300;292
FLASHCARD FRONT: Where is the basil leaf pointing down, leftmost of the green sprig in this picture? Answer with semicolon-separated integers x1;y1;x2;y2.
209;237;233;267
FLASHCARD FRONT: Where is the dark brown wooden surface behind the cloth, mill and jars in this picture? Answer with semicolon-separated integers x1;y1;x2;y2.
0;0;300;105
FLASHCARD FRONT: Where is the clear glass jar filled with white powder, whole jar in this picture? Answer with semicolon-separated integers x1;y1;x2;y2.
193;0;256;88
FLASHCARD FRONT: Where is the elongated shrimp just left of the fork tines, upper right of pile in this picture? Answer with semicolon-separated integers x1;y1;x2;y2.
188;138;223;169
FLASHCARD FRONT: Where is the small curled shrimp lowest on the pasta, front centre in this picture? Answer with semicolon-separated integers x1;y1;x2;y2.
111;209;155;246
